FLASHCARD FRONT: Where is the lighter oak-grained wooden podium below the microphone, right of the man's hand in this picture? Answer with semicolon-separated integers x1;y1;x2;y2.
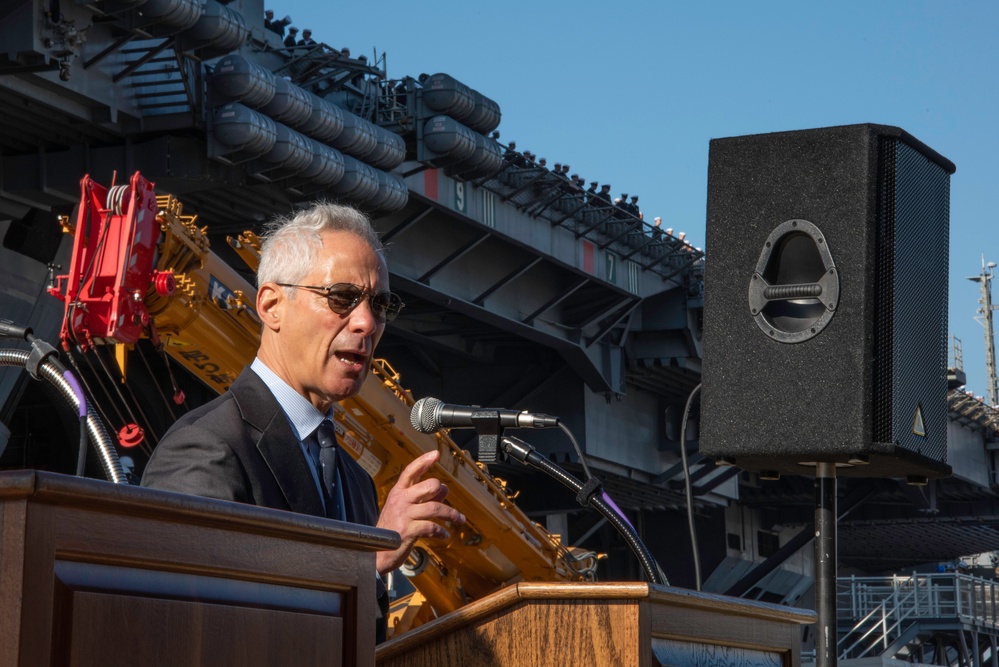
375;583;815;667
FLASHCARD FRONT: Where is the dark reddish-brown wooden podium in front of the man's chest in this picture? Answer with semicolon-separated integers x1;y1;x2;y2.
0;471;399;667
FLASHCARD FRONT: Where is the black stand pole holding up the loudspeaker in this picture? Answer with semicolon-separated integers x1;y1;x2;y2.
815;463;837;667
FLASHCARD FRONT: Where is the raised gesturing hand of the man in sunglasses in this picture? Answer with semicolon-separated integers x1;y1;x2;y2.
375;450;465;574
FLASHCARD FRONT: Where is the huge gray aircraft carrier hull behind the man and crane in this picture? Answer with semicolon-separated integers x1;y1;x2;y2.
0;0;999;664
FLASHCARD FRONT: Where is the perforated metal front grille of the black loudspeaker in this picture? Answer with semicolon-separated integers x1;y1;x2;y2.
873;137;950;462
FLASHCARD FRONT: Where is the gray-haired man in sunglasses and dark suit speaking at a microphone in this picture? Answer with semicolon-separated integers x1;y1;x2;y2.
142;203;465;636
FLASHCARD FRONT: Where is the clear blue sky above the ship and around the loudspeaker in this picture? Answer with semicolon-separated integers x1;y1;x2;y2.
278;0;999;402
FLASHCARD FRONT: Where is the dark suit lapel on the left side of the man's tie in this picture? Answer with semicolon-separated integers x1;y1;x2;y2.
230;370;326;517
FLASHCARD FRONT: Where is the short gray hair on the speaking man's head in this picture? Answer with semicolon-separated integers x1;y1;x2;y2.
257;201;382;286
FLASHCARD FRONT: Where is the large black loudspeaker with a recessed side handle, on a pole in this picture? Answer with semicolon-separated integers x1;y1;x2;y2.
700;125;954;482
